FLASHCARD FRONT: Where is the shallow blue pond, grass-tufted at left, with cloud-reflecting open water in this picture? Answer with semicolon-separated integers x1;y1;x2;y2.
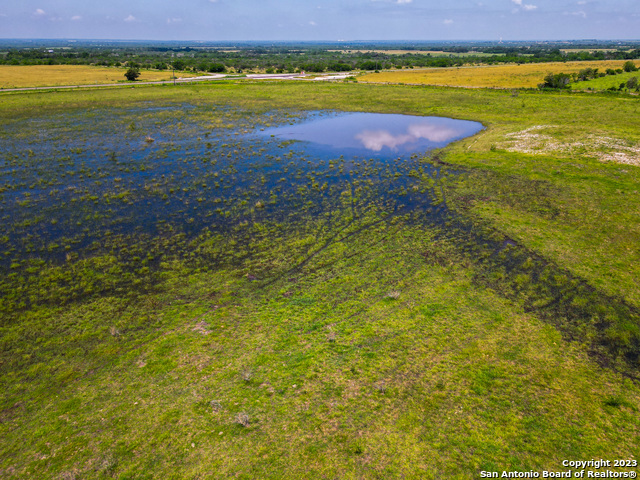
0;106;482;268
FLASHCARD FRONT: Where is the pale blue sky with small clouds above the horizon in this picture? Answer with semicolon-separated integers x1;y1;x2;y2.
0;0;640;41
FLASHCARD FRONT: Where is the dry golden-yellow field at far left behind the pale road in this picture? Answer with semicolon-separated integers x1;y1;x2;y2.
0;65;198;88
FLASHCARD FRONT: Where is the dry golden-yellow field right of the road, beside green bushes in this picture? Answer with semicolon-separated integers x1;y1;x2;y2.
358;60;624;88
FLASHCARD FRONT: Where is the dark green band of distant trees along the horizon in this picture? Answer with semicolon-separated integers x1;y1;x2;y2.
0;45;640;73
